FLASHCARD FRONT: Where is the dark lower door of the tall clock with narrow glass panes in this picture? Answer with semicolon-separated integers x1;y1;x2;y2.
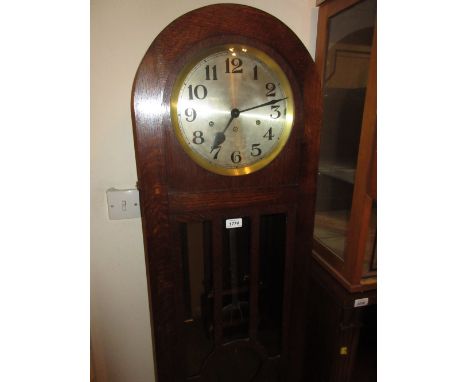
171;208;295;382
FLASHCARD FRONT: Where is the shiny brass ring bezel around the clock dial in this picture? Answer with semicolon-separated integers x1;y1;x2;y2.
170;43;294;176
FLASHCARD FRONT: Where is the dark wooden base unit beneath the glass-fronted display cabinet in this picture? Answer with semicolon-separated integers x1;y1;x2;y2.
305;254;377;382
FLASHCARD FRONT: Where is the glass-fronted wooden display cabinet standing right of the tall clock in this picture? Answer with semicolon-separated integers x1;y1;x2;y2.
313;0;377;292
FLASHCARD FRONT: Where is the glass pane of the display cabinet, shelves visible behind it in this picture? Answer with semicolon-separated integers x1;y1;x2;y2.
314;0;377;259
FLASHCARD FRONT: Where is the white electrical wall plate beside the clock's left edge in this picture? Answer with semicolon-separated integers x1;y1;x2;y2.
106;188;141;220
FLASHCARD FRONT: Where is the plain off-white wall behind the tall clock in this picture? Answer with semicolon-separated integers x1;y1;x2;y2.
91;0;317;382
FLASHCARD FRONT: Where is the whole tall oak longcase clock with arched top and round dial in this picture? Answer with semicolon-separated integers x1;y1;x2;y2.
132;4;321;382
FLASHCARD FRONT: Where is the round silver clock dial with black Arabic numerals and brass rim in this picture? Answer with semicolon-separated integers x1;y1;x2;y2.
171;44;294;175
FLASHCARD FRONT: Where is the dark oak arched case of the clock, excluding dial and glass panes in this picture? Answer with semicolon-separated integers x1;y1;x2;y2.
131;4;322;382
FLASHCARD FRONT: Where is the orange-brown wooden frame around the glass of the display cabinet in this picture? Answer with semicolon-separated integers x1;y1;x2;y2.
313;0;377;292
